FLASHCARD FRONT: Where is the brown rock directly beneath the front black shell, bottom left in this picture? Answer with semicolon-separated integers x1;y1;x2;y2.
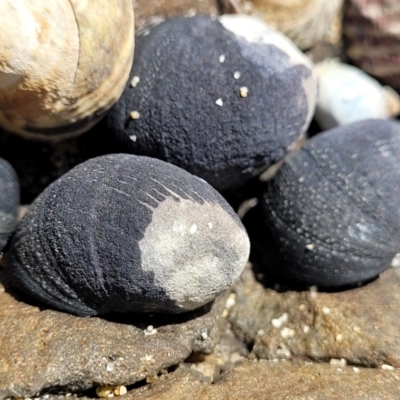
0;280;226;399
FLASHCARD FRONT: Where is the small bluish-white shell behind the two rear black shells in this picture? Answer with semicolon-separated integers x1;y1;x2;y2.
315;60;400;129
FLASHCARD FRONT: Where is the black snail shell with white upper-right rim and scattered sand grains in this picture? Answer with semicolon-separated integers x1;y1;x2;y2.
106;15;317;191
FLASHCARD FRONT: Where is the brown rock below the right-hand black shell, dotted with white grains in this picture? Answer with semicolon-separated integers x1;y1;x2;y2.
228;269;400;367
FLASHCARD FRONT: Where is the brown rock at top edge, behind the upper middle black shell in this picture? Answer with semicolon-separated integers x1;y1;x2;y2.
134;0;217;30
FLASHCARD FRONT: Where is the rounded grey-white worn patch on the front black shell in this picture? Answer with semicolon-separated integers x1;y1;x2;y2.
139;197;250;310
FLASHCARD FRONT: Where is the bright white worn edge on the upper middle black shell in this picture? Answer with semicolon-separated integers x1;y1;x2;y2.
218;14;317;131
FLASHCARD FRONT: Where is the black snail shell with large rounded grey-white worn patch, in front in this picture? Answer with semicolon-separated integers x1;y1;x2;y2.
6;154;249;316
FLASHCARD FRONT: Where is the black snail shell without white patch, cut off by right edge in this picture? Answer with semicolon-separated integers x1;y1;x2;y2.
262;120;400;287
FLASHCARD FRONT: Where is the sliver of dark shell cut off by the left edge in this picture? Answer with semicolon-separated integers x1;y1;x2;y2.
0;158;20;250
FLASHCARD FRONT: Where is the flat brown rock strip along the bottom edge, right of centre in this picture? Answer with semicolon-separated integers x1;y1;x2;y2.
111;361;400;400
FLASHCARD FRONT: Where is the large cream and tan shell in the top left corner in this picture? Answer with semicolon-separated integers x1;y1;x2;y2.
0;0;134;140
